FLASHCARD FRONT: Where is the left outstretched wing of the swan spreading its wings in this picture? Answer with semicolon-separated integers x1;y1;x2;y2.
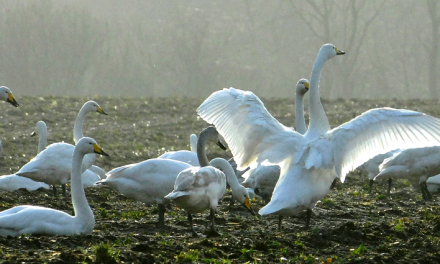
197;88;303;169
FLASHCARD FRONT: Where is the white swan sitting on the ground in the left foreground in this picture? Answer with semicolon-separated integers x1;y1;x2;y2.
0;137;108;236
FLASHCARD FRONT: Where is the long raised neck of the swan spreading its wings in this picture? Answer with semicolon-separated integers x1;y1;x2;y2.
306;49;330;138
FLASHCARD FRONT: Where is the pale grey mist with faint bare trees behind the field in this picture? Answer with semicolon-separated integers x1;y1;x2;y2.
0;0;440;99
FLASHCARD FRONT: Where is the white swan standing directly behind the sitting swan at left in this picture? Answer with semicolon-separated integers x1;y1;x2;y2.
15;101;107;196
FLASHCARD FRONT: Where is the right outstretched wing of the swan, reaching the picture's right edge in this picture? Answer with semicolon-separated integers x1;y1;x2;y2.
327;108;440;182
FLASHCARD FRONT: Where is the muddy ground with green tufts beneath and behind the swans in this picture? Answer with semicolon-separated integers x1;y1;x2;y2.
0;97;440;263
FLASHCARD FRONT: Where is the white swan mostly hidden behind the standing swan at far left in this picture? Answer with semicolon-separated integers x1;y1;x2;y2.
0;121;49;191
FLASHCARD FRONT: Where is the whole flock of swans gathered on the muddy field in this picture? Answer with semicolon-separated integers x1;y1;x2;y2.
0;44;440;236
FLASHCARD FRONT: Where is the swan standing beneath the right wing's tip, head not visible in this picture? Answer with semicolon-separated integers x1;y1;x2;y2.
374;146;440;200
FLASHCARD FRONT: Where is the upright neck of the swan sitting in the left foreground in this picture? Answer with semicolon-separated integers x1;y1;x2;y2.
70;147;94;222
